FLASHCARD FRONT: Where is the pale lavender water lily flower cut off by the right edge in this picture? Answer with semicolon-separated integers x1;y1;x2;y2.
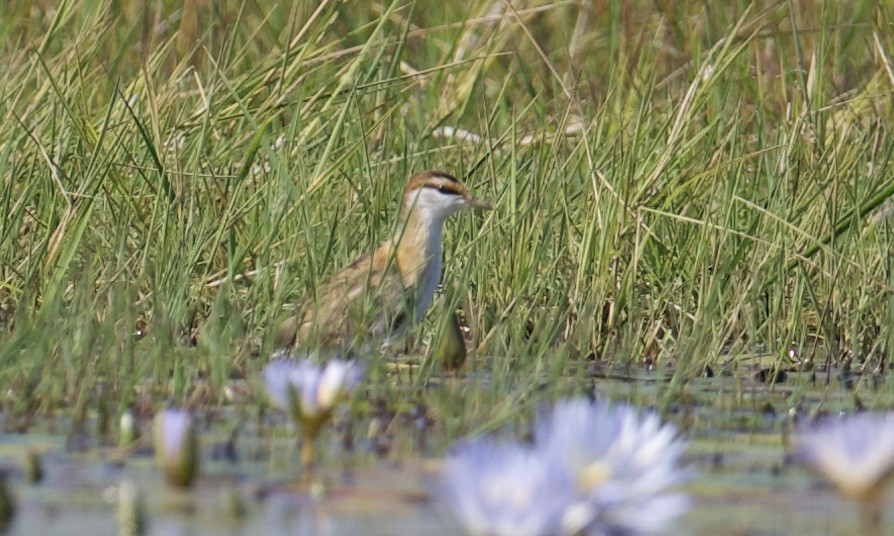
799;413;894;501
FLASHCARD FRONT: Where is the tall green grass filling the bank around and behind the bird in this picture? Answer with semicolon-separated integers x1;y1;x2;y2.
0;0;894;426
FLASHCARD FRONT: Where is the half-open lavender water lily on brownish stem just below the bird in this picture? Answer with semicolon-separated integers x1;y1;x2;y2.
264;359;363;469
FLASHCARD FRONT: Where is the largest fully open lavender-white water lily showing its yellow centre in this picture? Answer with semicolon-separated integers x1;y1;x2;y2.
535;398;691;534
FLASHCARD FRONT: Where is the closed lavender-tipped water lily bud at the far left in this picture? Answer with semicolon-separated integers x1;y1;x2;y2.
153;409;199;488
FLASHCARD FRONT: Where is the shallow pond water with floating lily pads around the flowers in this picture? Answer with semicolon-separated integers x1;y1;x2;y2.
0;368;894;536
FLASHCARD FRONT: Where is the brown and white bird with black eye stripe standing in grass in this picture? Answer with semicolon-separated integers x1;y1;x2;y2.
274;170;491;353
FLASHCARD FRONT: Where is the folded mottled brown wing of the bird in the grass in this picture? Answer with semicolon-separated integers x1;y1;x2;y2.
284;248;412;349
